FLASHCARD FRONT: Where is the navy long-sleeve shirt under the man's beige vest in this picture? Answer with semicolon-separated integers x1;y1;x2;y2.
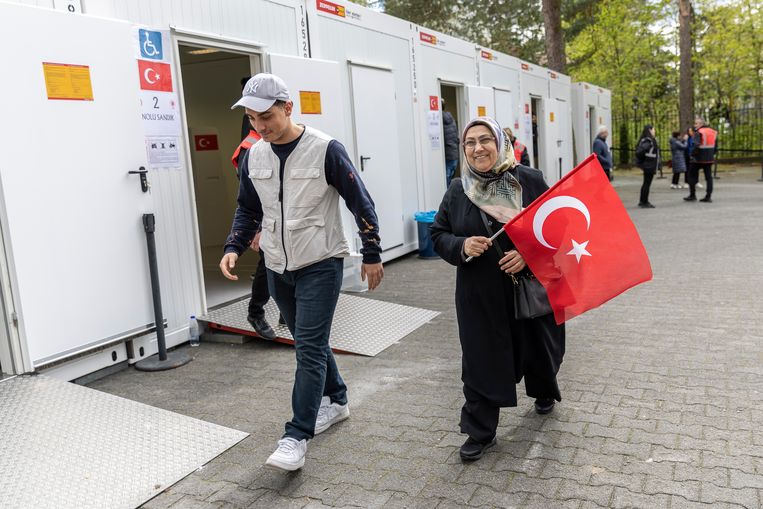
224;132;381;263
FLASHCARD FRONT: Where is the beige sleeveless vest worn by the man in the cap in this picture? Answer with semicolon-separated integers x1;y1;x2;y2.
249;127;349;274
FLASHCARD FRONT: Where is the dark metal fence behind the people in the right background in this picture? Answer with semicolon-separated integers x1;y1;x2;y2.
612;105;763;165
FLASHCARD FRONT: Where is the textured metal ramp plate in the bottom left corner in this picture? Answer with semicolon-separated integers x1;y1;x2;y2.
0;376;248;509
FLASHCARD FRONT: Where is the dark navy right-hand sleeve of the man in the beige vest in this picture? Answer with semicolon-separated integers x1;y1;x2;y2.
325;140;381;263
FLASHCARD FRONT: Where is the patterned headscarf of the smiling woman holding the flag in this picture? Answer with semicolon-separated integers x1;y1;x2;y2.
461;117;522;223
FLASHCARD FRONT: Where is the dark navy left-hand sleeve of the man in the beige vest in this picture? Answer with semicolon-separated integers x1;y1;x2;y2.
224;150;262;256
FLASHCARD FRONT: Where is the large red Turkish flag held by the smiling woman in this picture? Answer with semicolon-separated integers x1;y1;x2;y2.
504;154;652;324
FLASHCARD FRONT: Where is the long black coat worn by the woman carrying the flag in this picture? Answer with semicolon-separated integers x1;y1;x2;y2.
431;165;565;406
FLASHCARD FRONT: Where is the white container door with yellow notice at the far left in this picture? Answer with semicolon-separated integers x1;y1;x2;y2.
0;4;155;366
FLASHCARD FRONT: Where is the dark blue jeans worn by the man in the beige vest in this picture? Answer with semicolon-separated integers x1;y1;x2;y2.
268;258;347;440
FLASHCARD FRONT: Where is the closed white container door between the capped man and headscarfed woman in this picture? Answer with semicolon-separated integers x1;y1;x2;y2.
350;65;404;250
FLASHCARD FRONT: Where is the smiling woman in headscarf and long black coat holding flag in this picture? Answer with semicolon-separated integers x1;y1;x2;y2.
431;117;564;461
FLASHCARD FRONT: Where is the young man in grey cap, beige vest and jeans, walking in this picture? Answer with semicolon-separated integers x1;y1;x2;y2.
220;73;384;470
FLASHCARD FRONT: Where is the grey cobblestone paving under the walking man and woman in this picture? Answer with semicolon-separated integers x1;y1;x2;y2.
92;168;763;509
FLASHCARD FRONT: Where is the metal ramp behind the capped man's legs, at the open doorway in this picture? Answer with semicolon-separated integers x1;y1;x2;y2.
198;293;440;357
